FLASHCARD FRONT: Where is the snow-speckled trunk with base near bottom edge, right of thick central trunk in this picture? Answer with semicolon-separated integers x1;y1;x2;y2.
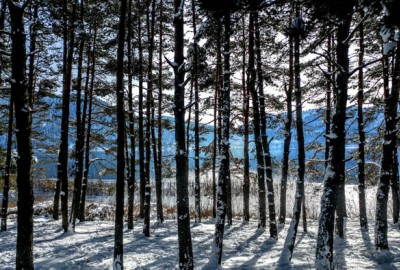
212;11;231;265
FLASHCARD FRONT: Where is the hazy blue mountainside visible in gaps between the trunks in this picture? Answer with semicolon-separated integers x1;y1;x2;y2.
0;94;383;180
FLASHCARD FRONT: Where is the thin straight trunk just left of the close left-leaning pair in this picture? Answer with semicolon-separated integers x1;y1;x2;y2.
242;16;250;221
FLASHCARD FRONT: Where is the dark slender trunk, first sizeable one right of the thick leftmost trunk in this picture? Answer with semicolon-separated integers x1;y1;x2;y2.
53;0;77;232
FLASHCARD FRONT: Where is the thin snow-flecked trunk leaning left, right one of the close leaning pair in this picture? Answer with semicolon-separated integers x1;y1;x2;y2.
254;12;278;238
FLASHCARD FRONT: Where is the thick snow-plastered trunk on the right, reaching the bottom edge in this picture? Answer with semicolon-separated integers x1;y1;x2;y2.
316;11;351;269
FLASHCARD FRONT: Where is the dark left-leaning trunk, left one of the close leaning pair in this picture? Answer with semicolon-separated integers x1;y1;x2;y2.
248;11;267;228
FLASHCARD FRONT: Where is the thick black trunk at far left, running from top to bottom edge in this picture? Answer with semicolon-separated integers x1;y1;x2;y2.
8;1;34;269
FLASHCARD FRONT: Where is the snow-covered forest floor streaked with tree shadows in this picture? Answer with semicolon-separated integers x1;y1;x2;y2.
0;202;400;270
